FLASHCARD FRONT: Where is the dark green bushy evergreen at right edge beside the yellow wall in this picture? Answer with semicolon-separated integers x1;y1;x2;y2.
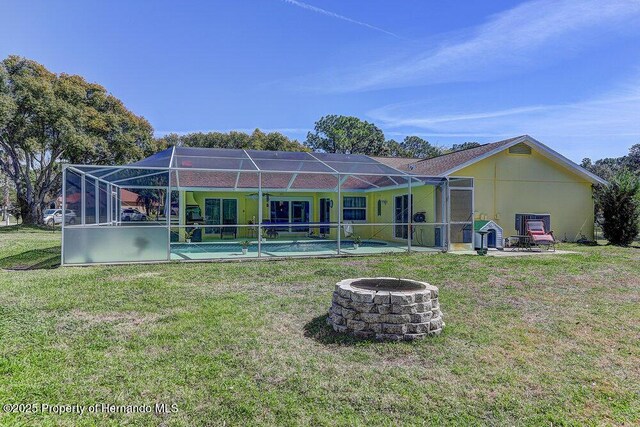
596;170;640;246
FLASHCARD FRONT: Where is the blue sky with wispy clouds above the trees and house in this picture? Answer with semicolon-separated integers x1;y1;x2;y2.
0;0;640;161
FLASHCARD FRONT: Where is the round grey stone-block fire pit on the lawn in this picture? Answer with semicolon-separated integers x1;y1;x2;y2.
327;277;444;341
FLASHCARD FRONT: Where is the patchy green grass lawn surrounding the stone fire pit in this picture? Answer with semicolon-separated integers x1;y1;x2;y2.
0;227;640;426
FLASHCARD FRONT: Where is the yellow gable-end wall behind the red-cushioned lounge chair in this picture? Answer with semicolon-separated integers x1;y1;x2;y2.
451;148;594;241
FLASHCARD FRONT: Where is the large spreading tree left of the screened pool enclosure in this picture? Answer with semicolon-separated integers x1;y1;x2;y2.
0;56;155;224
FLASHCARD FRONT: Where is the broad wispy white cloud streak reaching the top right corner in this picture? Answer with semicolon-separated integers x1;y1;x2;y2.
304;0;640;92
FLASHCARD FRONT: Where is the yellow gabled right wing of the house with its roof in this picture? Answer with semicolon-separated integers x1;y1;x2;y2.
377;135;605;246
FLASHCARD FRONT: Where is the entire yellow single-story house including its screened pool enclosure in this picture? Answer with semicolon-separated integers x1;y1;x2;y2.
62;136;603;264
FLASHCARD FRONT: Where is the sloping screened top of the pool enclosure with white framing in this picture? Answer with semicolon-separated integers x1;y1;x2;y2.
68;147;444;191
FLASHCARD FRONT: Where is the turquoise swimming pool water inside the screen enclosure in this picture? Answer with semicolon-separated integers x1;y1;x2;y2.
171;240;387;254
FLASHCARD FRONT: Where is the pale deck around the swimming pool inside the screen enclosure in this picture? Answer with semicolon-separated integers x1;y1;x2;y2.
171;239;441;260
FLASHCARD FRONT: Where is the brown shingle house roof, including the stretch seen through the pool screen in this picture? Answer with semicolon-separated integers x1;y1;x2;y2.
77;135;605;190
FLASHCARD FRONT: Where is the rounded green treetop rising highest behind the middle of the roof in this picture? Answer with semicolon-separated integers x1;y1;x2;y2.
305;115;389;156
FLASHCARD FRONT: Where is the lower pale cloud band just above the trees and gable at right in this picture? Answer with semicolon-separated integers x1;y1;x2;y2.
368;76;640;160
